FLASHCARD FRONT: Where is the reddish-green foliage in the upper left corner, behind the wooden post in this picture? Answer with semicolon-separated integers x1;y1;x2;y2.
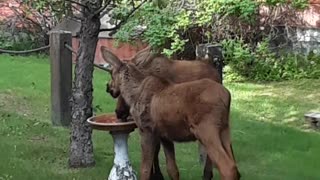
0;0;68;50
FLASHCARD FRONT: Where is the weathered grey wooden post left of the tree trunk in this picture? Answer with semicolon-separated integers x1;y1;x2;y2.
50;31;72;126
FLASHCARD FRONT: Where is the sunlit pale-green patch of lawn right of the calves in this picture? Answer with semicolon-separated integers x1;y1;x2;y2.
228;80;320;130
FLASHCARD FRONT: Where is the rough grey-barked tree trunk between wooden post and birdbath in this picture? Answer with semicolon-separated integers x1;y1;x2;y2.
69;0;102;168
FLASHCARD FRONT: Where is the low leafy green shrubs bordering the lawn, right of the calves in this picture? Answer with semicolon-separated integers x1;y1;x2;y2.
222;39;320;81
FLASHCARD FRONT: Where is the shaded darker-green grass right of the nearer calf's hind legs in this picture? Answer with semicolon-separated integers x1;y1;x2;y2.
232;110;320;180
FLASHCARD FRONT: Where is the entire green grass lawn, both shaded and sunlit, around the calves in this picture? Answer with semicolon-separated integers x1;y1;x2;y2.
0;55;320;180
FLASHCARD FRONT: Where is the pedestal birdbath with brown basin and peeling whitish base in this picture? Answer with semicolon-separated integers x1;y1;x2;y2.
87;114;137;180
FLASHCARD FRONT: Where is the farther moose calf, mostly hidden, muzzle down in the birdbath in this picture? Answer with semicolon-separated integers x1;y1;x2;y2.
107;47;221;180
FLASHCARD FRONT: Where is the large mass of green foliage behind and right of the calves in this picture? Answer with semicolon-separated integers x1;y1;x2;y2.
115;0;320;81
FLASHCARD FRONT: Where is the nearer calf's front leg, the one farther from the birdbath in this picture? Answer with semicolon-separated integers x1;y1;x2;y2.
161;139;179;180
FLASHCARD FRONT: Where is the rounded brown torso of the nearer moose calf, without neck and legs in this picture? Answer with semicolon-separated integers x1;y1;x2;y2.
150;79;230;141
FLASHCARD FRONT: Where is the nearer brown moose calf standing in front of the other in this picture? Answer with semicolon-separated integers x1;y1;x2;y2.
101;47;240;180
